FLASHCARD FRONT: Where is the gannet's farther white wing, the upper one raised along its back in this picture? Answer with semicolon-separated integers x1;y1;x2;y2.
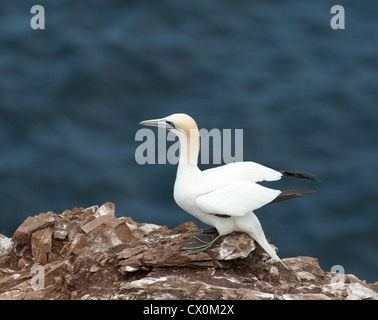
202;161;282;182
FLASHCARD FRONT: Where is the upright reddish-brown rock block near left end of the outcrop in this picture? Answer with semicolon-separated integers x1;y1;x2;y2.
31;228;52;264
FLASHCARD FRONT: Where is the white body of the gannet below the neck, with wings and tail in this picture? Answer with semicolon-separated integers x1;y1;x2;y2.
173;162;281;261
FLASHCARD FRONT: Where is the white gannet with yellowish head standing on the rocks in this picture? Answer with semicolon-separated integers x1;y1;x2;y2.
140;113;319;265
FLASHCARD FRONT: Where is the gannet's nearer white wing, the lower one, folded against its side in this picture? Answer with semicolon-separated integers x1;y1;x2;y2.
196;181;281;216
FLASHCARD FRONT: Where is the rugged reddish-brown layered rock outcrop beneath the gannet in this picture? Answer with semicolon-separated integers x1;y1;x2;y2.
0;203;378;300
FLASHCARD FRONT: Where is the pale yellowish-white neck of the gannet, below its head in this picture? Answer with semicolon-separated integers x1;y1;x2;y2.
178;129;200;167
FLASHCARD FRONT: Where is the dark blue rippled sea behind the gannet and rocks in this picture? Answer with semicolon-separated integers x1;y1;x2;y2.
0;0;378;282
